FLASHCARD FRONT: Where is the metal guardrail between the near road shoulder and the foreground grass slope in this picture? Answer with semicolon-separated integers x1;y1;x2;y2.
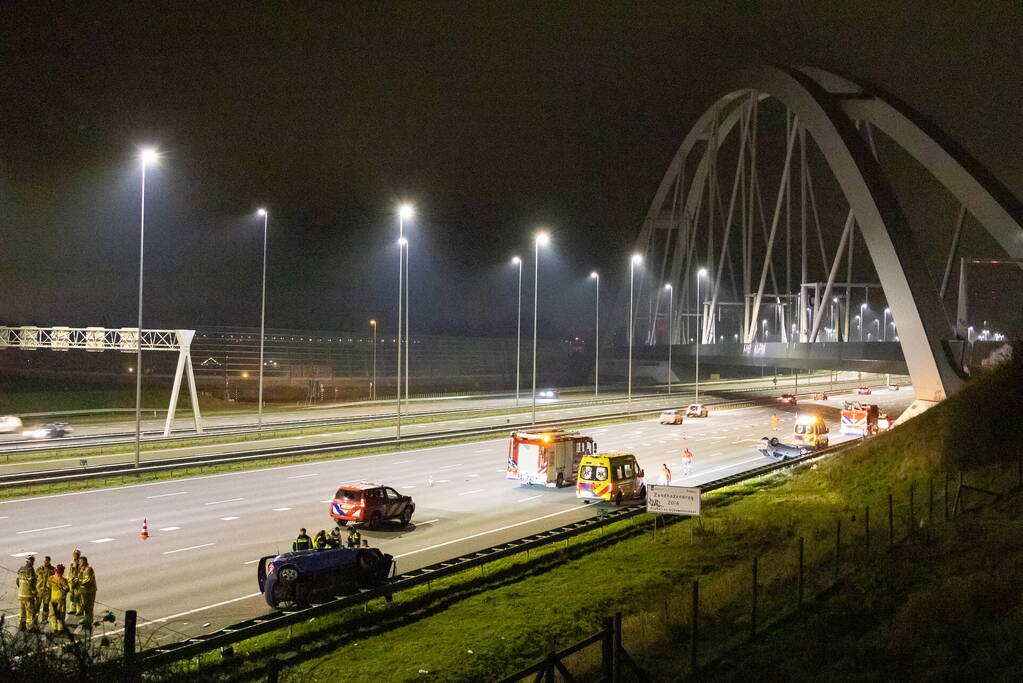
127;429;861;670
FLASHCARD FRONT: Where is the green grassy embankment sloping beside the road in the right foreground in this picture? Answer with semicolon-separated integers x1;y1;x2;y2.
149;355;1023;681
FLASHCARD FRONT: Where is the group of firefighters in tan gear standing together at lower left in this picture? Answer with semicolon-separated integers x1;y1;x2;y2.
16;548;96;633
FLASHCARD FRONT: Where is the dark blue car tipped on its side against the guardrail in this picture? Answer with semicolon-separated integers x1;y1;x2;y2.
258;548;394;607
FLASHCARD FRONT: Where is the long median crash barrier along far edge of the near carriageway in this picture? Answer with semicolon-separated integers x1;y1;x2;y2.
0;378;887;489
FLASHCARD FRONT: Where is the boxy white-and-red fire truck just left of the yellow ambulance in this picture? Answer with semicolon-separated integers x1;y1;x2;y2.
505;429;596;489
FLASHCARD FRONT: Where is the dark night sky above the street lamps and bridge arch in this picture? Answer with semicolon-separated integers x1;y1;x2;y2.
0;0;1023;336
